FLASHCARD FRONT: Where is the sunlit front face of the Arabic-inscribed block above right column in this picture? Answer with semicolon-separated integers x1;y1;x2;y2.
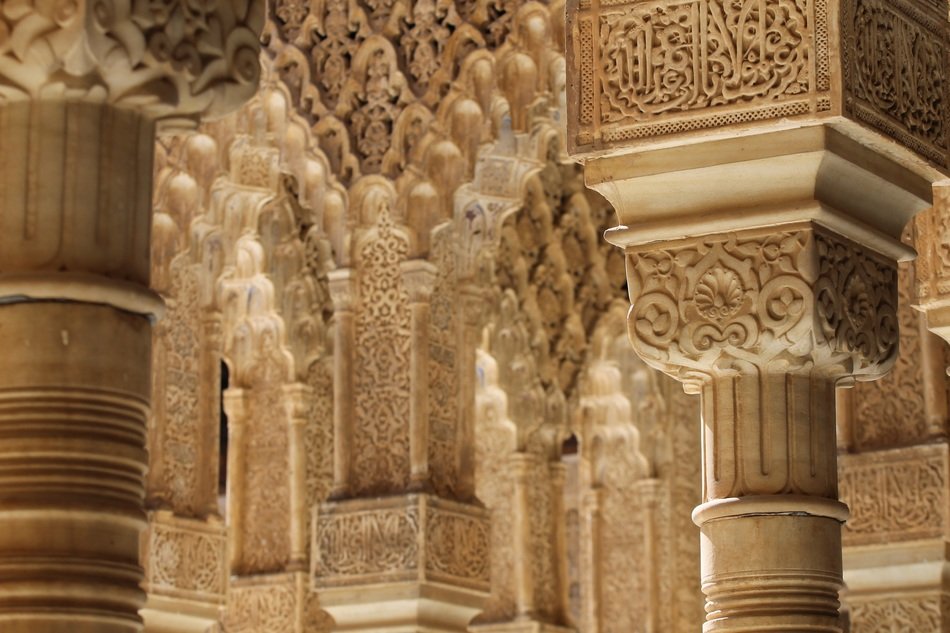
568;0;831;148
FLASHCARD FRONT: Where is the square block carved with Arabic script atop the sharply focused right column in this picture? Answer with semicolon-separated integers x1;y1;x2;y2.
567;0;950;169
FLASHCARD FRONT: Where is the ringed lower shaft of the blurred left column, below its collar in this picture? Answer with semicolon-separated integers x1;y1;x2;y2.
0;302;151;633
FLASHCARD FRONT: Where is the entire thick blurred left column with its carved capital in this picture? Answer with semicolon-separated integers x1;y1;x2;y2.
0;7;263;633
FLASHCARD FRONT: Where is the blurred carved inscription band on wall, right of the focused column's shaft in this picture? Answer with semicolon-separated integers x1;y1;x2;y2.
840;445;950;545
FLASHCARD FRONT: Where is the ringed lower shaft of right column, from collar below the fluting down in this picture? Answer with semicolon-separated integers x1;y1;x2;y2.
693;495;847;633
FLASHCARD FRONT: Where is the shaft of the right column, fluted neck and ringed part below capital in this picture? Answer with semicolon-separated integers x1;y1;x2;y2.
693;372;848;633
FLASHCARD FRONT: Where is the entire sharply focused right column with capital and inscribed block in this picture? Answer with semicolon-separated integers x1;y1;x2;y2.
567;0;950;633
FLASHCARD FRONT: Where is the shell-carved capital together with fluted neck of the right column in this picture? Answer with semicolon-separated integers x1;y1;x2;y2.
627;225;898;500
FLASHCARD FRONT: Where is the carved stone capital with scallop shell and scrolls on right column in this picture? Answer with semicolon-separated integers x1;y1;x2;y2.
627;223;898;392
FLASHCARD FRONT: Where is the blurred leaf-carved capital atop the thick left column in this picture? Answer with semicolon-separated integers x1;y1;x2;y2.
0;0;264;120
